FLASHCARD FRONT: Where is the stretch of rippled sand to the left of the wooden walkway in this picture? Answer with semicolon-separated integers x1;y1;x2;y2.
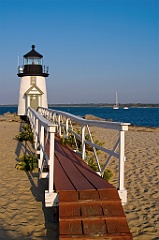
0;115;58;240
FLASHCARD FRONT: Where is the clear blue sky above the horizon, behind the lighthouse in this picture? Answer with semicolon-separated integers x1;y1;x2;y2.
0;0;159;104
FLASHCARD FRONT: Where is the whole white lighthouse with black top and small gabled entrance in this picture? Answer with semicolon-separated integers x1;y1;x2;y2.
17;45;49;116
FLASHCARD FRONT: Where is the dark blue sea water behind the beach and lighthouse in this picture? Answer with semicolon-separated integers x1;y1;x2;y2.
0;106;159;127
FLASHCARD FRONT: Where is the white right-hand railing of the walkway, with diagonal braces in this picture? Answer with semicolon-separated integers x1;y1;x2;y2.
38;107;130;204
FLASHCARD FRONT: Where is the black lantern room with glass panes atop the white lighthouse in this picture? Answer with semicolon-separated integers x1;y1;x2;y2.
17;45;49;77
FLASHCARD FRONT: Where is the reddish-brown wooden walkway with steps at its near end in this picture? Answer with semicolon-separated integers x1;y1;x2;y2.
54;137;132;240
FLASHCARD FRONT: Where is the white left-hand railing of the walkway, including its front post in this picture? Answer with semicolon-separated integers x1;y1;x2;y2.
27;107;58;207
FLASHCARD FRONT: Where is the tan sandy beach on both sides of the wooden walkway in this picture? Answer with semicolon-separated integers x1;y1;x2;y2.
0;113;159;240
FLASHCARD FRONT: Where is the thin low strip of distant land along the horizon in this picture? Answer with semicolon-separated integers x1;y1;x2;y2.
0;103;159;108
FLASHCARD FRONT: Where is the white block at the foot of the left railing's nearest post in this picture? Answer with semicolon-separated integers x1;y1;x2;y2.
45;190;59;207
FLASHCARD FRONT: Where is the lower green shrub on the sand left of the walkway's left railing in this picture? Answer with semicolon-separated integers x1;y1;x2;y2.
15;154;38;172
